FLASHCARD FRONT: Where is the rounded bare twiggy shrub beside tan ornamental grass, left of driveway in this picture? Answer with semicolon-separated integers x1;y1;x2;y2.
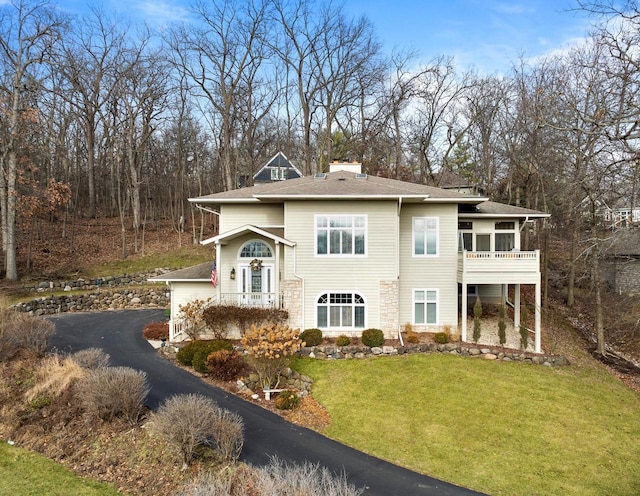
78;367;149;425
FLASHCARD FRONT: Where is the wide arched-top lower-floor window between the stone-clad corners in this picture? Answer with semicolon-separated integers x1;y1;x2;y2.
316;293;365;329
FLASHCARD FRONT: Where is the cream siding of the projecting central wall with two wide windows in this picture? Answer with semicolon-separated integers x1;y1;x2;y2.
285;201;397;334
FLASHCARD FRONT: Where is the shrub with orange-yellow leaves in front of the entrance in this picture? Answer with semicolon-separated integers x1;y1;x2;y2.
241;324;301;389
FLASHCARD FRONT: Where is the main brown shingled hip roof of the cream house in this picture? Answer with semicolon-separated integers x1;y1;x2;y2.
189;171;487;205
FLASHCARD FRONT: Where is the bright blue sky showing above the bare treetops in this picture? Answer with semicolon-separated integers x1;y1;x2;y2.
47;0;592;73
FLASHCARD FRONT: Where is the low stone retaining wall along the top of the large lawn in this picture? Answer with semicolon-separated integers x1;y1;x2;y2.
299;343;569;366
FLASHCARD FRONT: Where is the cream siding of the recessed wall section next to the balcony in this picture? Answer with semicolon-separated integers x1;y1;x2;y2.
400;204;458;329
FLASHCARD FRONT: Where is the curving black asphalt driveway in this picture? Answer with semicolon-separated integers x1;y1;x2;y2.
50;310;480;496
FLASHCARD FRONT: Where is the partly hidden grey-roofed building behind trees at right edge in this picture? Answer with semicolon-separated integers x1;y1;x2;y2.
601;229;640;295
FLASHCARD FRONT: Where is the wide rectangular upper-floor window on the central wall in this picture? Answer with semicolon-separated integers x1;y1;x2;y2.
316;215;367;255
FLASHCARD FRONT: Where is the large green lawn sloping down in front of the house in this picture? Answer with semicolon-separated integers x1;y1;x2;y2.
294;354;640;496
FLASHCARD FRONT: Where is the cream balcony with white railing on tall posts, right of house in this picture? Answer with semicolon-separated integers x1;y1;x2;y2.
458;250;540;284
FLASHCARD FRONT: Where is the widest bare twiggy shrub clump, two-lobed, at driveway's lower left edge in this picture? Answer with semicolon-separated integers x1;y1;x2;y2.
150;394;244;468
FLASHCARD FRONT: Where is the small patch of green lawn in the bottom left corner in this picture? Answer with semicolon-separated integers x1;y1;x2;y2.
0;442;121;496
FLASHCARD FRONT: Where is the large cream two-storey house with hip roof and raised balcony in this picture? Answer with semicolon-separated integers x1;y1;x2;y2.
154;164;548;351
